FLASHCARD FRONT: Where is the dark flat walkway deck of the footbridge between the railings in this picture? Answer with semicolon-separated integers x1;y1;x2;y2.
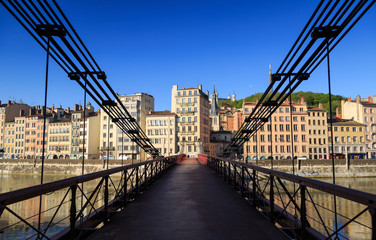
90;159;285;240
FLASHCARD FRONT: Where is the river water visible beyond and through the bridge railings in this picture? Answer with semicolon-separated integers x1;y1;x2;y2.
0;174;376;240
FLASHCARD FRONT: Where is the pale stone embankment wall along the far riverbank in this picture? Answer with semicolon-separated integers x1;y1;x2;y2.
0;159;376;177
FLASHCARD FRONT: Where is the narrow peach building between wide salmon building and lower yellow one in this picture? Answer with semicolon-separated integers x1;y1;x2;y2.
308;104;329;159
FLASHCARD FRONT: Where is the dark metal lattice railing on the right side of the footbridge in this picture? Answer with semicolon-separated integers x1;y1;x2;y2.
201;155;376;239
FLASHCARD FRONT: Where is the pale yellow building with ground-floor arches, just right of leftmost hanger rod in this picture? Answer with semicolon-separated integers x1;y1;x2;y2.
47;119;72;159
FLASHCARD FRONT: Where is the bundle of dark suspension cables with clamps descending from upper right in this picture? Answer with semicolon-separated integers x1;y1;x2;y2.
224;0;375;157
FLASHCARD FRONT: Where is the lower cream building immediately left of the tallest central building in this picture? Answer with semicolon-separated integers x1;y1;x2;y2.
146;111;178;156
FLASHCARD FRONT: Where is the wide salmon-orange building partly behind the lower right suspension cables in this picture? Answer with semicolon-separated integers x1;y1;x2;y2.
243;99;309;160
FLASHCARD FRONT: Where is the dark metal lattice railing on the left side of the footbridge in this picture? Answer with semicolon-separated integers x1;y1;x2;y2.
0;155;185;239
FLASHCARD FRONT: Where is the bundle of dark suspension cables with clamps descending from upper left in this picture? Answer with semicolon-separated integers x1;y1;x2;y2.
0;0;160;157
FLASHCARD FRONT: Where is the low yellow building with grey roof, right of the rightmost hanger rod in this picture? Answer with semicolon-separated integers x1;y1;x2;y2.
328;119;366;159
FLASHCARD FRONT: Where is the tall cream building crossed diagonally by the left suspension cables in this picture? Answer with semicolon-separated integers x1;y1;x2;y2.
100;93;154;160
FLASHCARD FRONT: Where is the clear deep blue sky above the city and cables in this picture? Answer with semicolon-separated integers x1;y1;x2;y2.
0;0;376;110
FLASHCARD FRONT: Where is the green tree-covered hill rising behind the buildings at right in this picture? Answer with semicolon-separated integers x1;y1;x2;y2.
219;92;346;114
